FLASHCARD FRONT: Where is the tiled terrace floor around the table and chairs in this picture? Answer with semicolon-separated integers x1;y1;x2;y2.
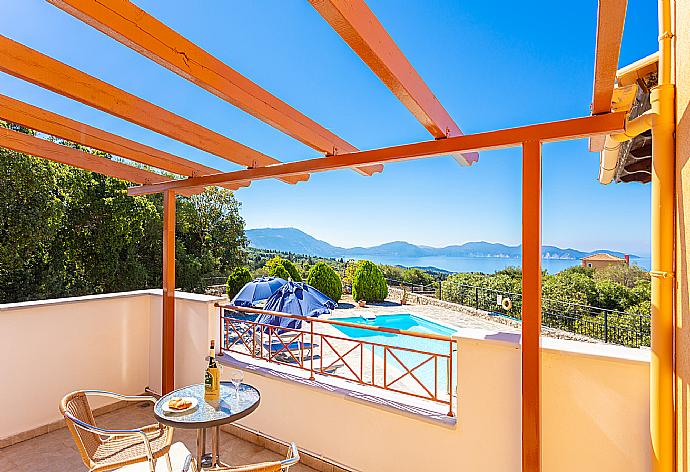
0;404;314;472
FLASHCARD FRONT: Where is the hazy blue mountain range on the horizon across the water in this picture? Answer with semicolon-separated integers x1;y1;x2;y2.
246;228;638;260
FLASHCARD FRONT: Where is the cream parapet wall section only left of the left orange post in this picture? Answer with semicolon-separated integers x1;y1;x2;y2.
0;292;149;438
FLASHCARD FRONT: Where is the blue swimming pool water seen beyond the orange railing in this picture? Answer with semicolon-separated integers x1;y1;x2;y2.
333;314;456;400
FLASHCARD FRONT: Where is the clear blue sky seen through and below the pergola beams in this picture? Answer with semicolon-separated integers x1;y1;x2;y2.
0;0;657;254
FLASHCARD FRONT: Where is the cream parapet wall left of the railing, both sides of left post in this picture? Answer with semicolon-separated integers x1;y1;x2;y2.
0;290;218;438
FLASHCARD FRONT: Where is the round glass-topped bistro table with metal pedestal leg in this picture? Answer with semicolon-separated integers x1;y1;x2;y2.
153;382;261;468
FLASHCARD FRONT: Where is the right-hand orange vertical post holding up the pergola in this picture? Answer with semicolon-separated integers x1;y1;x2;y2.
522;141;541;472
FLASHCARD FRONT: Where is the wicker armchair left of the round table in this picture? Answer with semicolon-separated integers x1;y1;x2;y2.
60;390;173;472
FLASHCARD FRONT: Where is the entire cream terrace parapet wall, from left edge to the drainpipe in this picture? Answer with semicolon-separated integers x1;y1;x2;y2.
0;291;650;472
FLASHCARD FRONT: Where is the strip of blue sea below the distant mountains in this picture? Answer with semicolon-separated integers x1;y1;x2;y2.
348;254;651;274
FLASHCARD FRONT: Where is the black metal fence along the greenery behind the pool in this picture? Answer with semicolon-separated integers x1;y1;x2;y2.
387;279;651;347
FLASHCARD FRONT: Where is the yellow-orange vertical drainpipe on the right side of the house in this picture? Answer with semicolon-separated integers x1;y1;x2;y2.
649;0;675;472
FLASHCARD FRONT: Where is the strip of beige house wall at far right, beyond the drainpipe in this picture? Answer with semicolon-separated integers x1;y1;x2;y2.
675;0;690;472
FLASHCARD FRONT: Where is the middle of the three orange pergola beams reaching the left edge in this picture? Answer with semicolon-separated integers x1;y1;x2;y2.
0;94;249;189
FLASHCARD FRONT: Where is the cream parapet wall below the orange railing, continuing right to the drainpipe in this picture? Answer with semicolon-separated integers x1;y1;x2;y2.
228;330;650;472
